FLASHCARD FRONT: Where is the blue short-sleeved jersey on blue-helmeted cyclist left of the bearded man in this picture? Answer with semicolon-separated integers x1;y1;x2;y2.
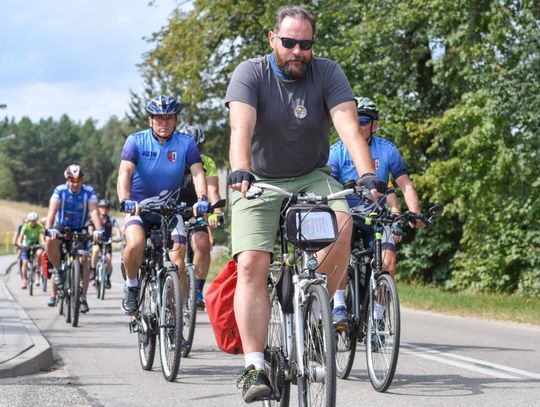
121;129;202;203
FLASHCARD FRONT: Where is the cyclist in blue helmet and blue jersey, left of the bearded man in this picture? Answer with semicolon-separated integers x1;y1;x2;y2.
117;96;209;315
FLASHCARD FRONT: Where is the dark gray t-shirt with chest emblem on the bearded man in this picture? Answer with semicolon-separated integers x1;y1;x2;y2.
225;55;354;178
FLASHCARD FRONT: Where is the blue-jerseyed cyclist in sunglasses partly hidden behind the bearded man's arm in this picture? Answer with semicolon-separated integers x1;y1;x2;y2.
328;98;426;324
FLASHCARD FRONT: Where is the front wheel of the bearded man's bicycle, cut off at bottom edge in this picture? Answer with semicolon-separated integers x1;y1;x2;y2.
298;284;336;407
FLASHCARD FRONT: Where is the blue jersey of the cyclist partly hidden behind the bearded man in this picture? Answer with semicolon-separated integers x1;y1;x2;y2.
328;136;407;211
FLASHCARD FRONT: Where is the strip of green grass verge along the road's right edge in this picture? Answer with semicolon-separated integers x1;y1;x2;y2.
398;282;540;325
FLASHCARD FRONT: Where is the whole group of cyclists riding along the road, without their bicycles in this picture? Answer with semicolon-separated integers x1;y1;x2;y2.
7;6;425;403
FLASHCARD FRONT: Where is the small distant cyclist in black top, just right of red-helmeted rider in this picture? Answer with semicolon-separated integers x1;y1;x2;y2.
88;199;122;288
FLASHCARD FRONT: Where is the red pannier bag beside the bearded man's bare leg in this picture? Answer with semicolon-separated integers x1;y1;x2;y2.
204;259;244;355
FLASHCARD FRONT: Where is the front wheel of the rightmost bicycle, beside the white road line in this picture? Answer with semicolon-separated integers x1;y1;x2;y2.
366;274;401;392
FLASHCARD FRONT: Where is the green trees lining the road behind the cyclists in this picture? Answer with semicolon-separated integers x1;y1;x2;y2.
0;0;540;296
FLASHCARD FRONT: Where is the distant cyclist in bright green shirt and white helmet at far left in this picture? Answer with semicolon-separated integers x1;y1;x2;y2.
17;212;45;289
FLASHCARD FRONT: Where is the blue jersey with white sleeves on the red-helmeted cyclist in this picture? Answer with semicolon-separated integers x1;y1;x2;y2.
51;184;97;230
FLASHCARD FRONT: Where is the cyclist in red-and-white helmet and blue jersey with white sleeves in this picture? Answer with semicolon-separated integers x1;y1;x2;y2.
45;164;102;313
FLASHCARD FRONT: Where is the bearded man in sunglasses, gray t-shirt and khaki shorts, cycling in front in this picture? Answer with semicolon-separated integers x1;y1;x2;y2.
225;6;386;403
